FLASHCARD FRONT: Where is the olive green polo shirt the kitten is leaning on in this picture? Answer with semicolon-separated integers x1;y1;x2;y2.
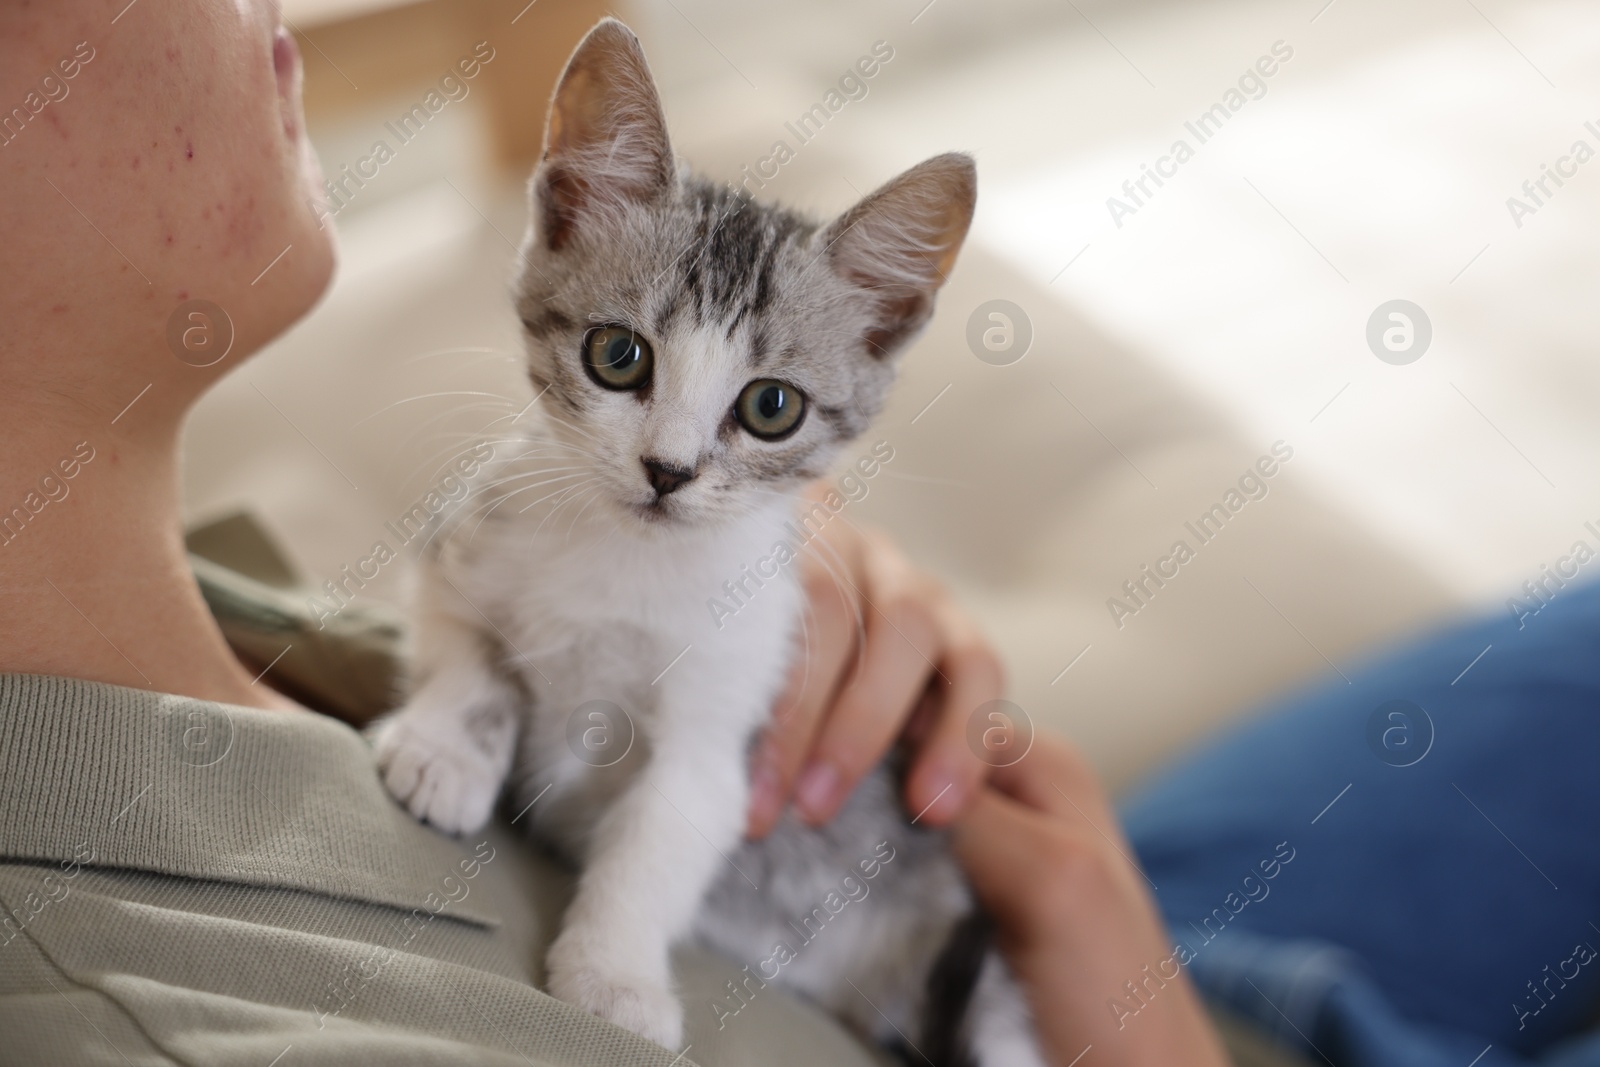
0;520;1299;1067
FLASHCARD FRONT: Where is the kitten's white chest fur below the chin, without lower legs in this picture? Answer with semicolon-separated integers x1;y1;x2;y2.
440;460;800;857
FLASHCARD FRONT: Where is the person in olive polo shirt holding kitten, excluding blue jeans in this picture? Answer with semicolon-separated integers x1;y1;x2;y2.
0;0;1222;1067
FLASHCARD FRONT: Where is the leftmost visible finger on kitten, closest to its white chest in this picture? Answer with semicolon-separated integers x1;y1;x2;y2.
747;558;862;838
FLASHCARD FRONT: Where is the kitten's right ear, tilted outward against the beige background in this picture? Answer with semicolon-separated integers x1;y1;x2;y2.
822;152;978;358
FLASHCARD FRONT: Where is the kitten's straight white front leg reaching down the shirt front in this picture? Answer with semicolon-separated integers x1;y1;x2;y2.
547;672;755;1049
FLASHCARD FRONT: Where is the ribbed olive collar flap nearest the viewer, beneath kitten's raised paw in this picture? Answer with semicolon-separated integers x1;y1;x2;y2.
0;673;498;925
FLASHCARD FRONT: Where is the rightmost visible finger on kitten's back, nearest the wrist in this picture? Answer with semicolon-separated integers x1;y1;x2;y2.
906;601;1005;825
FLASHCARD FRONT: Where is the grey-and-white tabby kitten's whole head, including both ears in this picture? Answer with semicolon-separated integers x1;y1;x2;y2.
517;21;974;526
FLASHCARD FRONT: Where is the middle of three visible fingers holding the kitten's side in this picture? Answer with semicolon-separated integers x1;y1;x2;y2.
795;543;941;825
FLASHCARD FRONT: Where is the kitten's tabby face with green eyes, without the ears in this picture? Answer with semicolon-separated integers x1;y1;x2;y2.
520;182;891;534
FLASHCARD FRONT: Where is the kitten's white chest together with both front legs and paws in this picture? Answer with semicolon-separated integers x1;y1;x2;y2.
374;435;800;1046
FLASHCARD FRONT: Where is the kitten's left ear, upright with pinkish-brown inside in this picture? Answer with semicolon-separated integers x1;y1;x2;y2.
533;19;674;250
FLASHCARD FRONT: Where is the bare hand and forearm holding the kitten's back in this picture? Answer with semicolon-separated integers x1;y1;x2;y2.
749;505;1227;1067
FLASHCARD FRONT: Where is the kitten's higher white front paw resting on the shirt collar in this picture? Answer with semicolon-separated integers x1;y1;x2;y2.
373;715;501;833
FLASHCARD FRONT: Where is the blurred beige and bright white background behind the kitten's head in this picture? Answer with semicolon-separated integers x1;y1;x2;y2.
187;0;1600;785
